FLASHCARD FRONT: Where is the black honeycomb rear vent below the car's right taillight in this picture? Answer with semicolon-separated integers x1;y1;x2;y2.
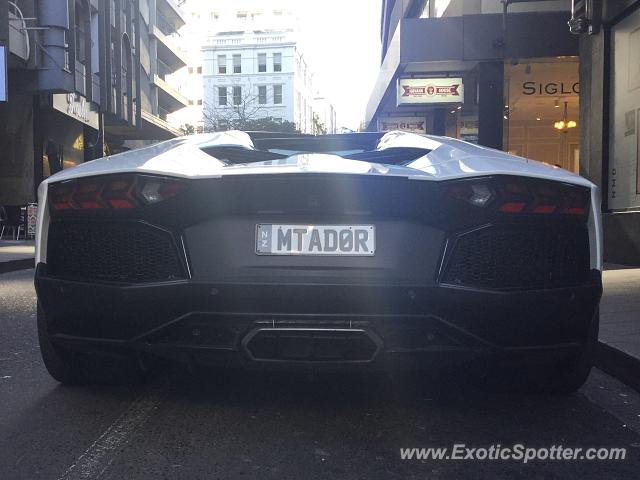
442;227;589;290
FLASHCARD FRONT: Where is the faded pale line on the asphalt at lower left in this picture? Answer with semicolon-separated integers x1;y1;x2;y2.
58;380;170;480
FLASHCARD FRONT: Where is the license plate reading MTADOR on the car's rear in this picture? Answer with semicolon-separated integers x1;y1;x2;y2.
256;224;376;256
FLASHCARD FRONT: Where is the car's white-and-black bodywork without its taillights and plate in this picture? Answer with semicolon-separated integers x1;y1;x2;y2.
36;132;602;376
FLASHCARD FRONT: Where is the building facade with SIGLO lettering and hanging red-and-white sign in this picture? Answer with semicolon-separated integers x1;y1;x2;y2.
365;0;580;172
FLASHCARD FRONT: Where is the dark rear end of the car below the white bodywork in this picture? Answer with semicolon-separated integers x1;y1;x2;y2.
36;158;601;382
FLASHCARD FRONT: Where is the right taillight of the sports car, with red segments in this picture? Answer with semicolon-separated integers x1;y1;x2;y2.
444;177;591;216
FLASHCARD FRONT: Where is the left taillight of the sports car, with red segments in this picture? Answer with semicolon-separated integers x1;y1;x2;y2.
49;175;187;211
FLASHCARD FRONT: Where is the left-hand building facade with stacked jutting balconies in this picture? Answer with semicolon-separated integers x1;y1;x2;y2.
0;0;186;204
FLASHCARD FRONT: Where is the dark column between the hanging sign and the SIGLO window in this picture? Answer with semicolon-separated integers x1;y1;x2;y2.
478;62;504;150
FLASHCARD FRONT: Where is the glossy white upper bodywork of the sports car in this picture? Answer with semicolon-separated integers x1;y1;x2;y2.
36;131;602;269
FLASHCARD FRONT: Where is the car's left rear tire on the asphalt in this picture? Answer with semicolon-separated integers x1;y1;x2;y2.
37;303;144;385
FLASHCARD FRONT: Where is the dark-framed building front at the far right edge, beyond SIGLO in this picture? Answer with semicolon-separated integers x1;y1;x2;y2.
575;0;640;265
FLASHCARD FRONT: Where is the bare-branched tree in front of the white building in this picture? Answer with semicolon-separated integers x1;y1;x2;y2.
202;83;298;133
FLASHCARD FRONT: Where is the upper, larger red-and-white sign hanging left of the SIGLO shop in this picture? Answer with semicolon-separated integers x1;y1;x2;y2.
398;78;464;105
